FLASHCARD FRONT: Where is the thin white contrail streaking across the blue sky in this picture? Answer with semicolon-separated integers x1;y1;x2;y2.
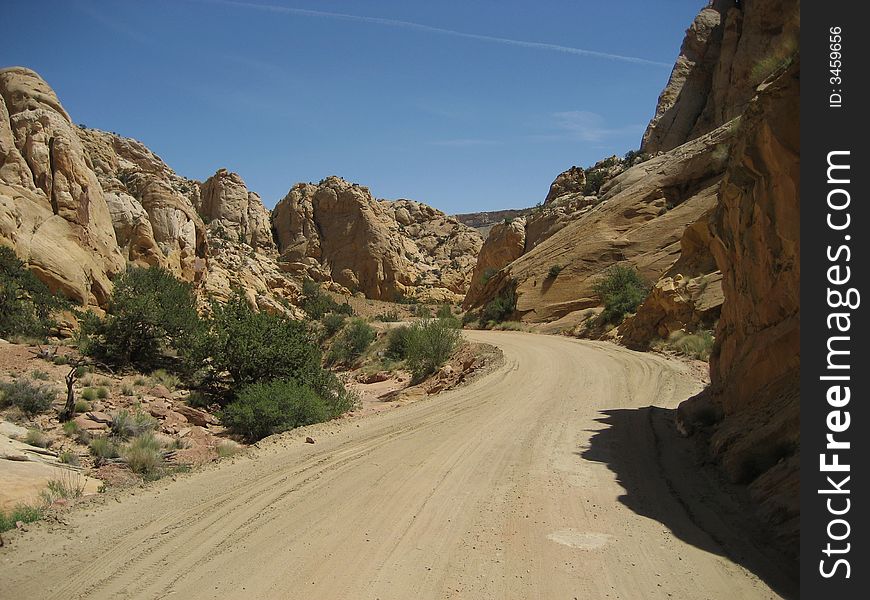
191;0;672;68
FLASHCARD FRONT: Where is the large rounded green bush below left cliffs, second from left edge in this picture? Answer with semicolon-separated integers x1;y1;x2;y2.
80;267;201;366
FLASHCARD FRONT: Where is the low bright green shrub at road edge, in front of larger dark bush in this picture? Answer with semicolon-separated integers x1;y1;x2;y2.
221;380;334;441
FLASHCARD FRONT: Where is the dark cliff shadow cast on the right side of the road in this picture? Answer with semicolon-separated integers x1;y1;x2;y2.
576;406;799;598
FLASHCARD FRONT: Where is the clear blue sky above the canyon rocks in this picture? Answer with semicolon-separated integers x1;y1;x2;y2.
0;0;703;213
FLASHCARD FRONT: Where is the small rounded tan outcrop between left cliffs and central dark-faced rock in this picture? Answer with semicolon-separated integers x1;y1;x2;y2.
197;169;277;252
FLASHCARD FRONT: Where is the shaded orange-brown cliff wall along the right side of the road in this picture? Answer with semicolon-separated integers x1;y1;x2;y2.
696;60;800;539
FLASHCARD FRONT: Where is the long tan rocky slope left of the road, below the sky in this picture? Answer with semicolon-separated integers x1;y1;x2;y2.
0;67;482;312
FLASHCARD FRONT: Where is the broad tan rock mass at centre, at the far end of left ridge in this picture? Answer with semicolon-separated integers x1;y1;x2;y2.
272;177;482;302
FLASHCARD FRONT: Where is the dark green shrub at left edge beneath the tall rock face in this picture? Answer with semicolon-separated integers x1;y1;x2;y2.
0;246;69;337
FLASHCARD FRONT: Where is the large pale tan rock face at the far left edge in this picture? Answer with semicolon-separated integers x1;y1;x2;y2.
0;67;125;305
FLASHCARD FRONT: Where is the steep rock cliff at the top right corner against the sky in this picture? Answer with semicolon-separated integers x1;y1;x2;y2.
641;0;800;152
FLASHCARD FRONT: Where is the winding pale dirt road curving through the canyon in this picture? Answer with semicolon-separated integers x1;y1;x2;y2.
0;332;778;600
